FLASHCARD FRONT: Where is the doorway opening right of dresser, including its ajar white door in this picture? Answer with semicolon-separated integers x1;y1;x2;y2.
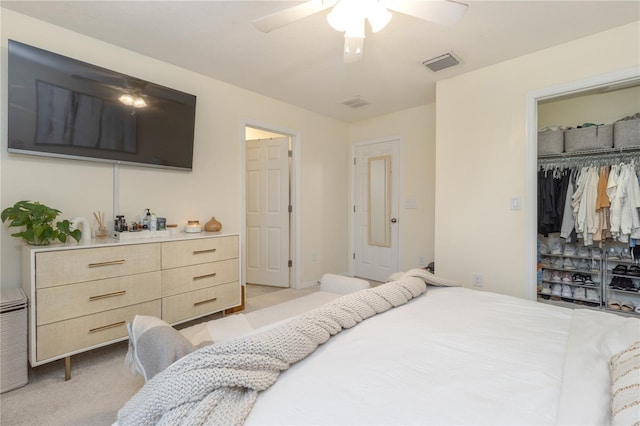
242;122;299;288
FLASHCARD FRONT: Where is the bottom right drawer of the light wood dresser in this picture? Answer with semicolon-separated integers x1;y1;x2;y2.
162;281;240;324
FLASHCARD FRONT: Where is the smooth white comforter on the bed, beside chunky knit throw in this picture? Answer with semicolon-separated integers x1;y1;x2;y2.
247;287;640;425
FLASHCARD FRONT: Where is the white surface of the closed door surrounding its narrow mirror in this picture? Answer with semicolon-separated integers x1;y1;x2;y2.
353;141;399;282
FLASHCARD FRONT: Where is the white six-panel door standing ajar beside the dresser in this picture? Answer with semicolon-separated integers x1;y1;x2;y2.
246;137;290;287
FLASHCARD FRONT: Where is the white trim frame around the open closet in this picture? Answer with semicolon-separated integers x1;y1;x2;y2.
524;67;640;300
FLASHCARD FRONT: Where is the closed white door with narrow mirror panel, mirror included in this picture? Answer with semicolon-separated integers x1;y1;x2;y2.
353;140;399;282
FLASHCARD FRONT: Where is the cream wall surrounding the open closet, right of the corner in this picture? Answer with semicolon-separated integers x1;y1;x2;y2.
435;22;640;297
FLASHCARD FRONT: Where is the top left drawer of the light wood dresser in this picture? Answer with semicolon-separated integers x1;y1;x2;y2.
35;243;160;289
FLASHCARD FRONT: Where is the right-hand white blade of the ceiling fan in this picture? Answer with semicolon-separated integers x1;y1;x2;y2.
384;0;469;25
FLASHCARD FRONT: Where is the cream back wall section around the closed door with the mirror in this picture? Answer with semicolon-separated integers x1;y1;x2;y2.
349;104;436;271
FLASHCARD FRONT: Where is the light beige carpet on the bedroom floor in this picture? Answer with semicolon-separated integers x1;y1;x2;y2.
0;285;318;426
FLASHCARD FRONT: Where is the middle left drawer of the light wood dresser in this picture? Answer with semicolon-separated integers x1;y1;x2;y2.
36;271;162;325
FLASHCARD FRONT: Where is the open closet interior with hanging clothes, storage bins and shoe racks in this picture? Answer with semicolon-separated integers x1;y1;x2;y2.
537;85;640;316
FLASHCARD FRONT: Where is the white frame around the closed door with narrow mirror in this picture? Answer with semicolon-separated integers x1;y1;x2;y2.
349;136;403;276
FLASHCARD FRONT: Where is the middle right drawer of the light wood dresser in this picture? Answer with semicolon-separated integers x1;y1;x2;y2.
162;259;239;297
